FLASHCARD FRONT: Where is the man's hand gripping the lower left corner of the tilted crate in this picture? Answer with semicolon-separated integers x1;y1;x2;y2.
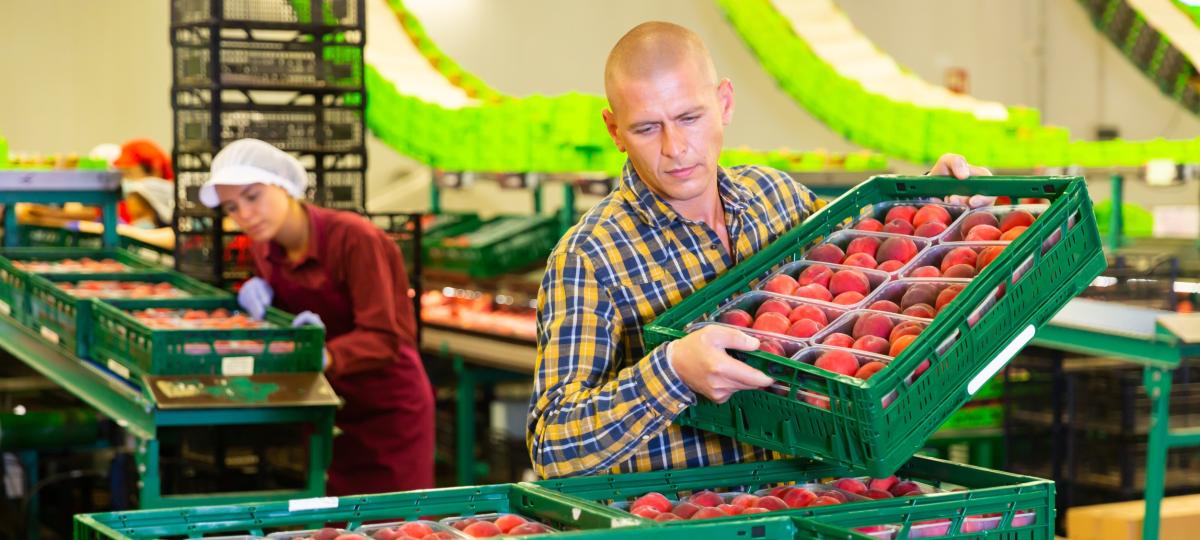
667;325;775;403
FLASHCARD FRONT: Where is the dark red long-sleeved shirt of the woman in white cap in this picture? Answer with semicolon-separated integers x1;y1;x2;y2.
251;204;420;377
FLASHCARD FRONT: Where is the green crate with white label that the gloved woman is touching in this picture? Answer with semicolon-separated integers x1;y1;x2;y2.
89;296;325;379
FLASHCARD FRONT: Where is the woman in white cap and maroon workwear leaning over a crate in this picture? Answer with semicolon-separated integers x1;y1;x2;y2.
199;139;433;496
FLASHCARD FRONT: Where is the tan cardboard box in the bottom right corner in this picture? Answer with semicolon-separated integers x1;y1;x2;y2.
1067;494;1200;540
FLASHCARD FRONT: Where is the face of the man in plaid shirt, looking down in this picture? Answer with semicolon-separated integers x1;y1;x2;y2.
604;62;733;203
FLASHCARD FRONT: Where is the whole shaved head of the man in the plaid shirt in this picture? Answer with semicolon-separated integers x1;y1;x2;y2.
604;22;733;203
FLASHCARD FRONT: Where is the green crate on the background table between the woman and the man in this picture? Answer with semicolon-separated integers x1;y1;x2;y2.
425;216;559;277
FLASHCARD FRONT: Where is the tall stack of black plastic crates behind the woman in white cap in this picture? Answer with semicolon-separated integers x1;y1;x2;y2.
170;0;367;284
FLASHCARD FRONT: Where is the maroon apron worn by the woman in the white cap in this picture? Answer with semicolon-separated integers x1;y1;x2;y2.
269;265;433;496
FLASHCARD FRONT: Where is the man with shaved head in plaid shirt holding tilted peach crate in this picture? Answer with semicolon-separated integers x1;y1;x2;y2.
527;22;988;478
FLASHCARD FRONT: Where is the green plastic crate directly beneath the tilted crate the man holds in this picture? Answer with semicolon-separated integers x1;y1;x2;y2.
534;456;1055;540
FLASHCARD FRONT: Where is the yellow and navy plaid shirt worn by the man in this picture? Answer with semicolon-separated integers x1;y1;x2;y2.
527;162;820;478
